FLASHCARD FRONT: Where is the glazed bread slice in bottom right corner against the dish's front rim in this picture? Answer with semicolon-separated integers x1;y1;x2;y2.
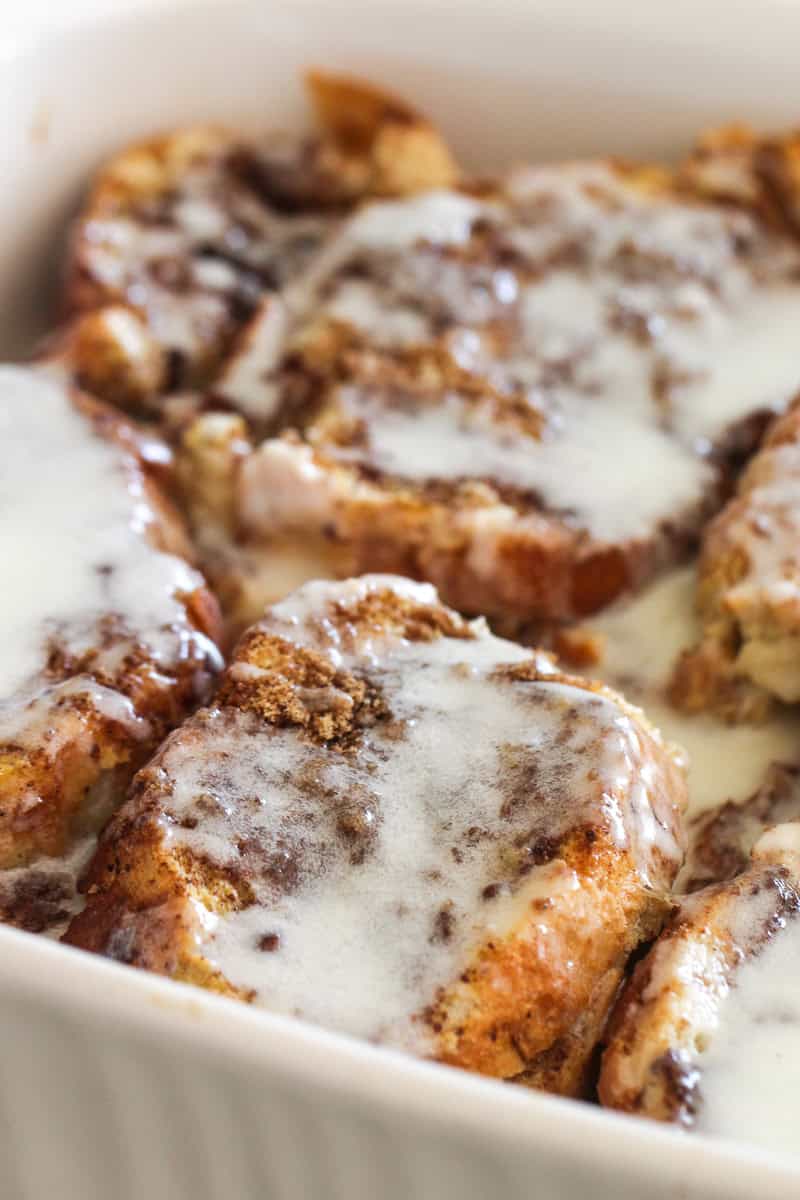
600;823;800;1123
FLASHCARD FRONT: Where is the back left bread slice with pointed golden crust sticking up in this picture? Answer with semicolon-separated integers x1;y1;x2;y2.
59;72;457;424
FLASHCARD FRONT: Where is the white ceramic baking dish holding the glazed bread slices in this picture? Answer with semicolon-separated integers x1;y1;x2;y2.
0;0;800;1200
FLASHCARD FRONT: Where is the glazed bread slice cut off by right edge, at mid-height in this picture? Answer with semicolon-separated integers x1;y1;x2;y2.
672;404;800;720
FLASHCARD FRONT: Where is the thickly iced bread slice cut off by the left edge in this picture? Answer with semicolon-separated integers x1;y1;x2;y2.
0;367;221;924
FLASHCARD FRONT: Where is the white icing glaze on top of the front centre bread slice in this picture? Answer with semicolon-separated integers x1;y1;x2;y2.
161;576;676;1051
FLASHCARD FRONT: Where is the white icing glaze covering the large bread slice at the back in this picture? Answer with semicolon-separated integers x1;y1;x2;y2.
242;164;800;541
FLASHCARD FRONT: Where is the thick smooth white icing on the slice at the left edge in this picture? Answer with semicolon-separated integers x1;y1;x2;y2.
0;367;218;739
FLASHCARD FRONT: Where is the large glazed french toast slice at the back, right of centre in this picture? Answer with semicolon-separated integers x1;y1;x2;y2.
185;147;800;622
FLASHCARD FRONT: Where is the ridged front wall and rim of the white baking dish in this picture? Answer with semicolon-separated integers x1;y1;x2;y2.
0;929;798;1200
